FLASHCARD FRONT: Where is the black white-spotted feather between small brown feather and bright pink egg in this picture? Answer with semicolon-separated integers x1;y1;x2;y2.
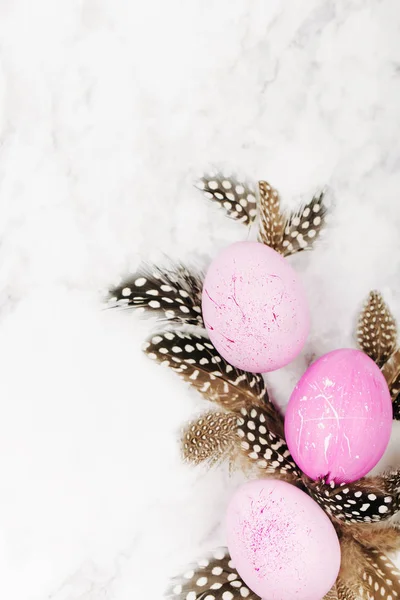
237;403;301;482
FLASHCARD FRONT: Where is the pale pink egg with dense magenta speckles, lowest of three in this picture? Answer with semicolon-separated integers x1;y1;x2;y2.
226;479;340;600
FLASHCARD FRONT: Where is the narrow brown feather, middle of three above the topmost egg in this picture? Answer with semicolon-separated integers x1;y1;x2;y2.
258;181;285;252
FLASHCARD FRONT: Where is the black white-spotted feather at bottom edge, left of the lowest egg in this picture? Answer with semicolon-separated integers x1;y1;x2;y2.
166;548;261;600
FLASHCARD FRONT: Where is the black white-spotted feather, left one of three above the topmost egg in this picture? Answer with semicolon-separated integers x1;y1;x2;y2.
196;173;257;225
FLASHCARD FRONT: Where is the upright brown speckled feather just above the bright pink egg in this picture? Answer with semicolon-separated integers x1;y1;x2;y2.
357;291;397;367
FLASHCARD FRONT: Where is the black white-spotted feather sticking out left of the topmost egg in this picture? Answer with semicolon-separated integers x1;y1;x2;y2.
109;264;203;325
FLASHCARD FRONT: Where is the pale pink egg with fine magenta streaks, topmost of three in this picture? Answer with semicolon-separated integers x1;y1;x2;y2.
202;242;310;373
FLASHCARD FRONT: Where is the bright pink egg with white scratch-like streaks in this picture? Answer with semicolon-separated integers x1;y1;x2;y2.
285;349;393;483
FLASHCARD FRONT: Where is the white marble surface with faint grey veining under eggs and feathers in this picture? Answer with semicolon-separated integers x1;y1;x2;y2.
0;0;400;600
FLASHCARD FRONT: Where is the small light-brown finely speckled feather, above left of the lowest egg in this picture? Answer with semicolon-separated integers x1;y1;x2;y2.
182;412;237;466
